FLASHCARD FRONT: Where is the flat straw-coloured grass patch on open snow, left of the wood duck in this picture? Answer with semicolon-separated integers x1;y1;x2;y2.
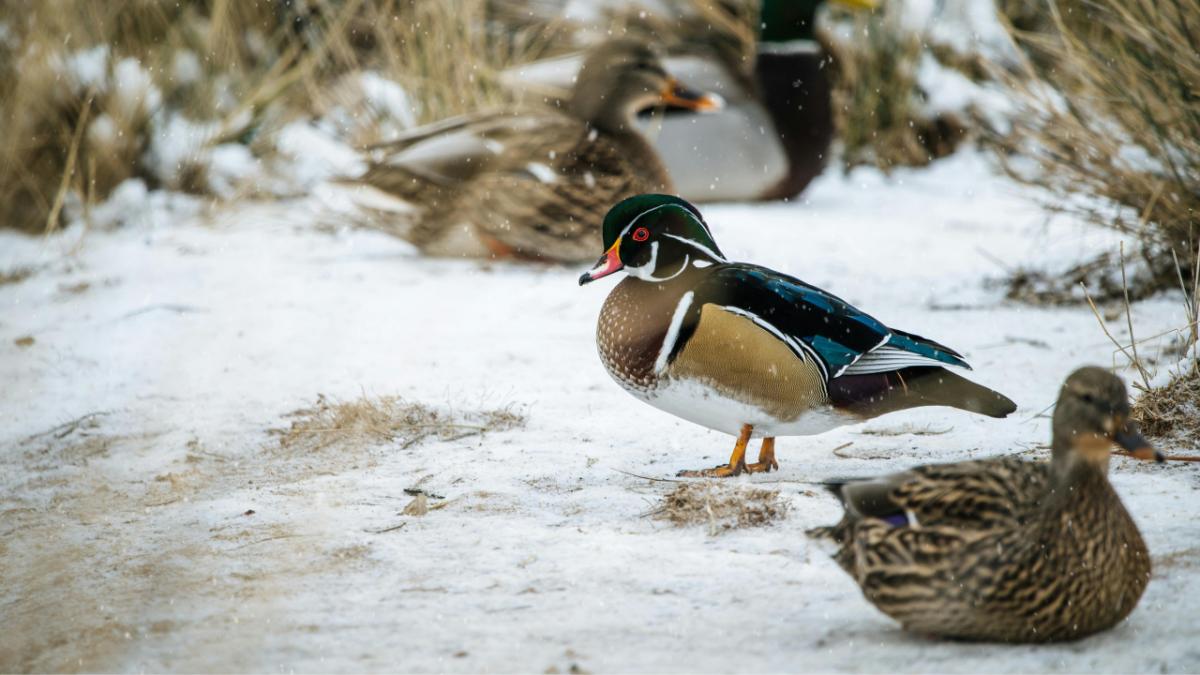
272;395;526;453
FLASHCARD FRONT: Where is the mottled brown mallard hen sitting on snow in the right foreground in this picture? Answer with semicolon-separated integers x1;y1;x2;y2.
810;368;1163;643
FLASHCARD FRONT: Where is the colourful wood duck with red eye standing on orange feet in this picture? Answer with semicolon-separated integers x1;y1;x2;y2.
580;195;1016;477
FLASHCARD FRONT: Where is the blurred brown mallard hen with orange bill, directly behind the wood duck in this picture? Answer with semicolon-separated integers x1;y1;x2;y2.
338;38;721;262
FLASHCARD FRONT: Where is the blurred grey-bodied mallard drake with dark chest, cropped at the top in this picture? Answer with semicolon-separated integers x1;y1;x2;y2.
505;0;878;202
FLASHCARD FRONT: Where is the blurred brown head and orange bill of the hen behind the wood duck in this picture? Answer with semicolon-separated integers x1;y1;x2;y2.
571;38;724;131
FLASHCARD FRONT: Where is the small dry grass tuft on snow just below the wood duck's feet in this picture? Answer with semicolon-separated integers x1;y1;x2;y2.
653;480;788;534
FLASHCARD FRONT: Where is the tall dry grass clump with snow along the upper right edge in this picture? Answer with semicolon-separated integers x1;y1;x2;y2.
998;0;1200;293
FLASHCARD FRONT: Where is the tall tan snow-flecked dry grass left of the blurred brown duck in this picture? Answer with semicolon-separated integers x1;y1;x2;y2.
0;0;559;232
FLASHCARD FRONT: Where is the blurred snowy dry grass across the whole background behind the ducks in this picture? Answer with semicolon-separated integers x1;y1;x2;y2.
0;0;1200;296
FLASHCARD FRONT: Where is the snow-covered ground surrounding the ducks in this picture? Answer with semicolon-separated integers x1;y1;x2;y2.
0;154;1200;671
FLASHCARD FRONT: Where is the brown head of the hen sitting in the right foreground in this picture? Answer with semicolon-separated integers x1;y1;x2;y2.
1054;366;1163;466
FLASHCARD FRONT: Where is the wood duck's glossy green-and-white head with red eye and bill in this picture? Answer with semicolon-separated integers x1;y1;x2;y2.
580;195;726;286
